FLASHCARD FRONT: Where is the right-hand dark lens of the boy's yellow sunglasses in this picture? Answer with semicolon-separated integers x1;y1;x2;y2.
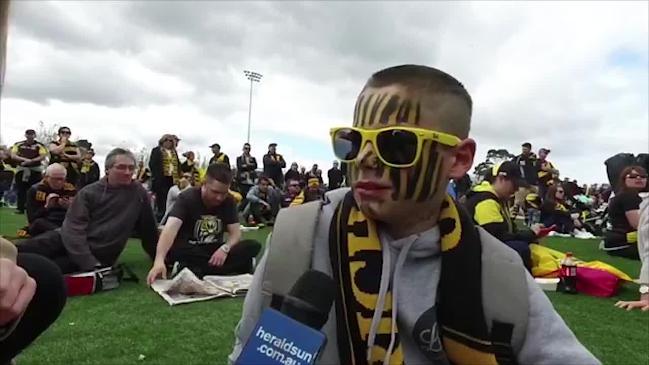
376;129;417;165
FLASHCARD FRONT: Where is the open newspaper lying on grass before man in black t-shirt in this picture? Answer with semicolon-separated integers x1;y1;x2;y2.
151;268;252;305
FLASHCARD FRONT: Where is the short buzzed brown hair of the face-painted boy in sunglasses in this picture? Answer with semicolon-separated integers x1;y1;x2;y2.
361;65;473;138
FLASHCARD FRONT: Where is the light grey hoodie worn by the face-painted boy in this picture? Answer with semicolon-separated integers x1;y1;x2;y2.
229;189;600;365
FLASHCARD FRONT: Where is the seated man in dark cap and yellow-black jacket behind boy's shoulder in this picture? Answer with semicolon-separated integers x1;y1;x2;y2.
465;161;538;271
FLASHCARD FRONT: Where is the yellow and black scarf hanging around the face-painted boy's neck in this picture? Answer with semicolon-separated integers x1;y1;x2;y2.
329;192;515;365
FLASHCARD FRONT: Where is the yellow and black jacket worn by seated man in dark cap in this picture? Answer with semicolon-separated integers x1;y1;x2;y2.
464;181;536;242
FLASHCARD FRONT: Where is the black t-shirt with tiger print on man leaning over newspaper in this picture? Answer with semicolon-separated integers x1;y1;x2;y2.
169;187;239;254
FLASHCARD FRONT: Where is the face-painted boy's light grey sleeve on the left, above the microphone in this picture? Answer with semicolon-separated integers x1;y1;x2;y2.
228;240;270;364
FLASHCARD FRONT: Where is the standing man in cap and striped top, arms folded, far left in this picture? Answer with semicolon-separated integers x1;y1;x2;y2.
11;129;47;214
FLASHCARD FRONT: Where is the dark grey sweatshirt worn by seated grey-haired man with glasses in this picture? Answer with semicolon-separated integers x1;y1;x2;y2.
61;178;158;270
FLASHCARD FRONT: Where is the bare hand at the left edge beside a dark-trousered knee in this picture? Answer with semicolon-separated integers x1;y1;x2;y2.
0;259;36;327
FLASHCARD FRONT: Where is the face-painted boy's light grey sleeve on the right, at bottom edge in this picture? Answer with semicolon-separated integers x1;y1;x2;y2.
518;274;601;365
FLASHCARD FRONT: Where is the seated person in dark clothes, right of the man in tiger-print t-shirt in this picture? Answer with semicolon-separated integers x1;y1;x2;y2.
243;176;279;225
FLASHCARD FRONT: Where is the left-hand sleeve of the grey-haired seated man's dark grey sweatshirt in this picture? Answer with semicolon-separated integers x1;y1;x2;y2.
61;189;100;271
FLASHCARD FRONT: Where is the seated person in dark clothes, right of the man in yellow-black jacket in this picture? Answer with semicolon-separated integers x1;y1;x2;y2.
541;185;593;238
